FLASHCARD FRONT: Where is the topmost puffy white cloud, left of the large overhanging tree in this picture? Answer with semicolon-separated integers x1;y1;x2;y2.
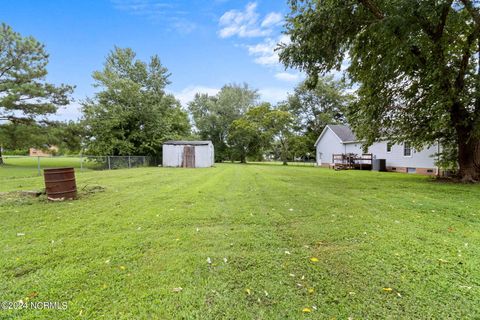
219;2;282;38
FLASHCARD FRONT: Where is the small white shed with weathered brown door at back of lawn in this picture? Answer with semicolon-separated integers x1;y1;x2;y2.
162;141;215;168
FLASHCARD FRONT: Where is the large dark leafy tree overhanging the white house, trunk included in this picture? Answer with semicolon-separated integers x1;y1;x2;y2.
280;0;480;181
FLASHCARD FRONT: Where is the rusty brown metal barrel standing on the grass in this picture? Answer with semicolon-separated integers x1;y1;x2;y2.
43;168;77;200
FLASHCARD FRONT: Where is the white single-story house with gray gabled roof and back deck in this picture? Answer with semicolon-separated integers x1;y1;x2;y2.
315;125;439;175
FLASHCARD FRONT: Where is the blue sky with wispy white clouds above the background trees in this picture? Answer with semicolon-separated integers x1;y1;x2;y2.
0;0;302;119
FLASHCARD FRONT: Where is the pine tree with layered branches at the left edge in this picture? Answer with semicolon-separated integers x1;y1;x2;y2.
0;23;73;164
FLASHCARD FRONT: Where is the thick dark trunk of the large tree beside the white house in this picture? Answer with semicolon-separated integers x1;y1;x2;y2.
458;132;480;182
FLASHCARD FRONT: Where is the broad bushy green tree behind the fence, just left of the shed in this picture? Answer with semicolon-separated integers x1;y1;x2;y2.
82;47;190;157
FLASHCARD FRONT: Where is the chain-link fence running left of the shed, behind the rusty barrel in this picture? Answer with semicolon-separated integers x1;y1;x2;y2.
0;155;154;175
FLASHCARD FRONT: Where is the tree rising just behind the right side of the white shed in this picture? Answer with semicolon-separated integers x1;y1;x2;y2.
188;84;258;161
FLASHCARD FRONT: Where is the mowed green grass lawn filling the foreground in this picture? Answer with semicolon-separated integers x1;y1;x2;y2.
0;164;480;319
